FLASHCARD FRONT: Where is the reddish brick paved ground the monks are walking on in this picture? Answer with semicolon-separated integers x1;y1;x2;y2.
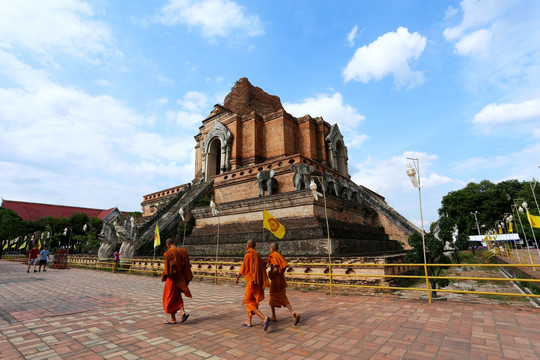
0;261;540;360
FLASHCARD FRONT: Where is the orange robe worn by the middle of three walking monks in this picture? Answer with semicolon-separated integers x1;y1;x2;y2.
240;248;270;315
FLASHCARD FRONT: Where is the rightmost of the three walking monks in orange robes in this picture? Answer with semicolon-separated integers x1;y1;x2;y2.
266;243;300;325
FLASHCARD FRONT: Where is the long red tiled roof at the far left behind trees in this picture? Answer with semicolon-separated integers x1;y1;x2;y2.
2;200;120;221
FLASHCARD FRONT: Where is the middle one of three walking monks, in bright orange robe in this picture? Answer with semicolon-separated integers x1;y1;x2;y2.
236;240;270;331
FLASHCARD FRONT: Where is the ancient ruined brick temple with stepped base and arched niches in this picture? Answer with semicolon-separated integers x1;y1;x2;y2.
132;78;418;256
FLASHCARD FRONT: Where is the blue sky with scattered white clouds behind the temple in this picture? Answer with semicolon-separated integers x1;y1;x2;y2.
0;0;540;228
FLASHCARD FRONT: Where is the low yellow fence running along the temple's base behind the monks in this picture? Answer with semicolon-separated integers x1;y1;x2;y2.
2;256;540;302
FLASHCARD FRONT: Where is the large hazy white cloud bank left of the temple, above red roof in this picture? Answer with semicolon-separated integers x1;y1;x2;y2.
0;50;195;210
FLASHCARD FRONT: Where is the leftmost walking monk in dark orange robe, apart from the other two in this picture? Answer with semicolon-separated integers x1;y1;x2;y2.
161;238;193;324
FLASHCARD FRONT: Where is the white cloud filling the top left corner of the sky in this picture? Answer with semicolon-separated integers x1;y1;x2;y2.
0;0;113;62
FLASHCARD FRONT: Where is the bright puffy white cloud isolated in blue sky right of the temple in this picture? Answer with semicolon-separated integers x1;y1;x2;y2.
343;27;426;89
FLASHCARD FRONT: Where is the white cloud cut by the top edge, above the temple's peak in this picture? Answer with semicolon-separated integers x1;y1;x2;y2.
158;0;264;38
